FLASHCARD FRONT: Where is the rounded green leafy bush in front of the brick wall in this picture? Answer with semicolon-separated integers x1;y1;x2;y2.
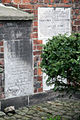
41;33;80;89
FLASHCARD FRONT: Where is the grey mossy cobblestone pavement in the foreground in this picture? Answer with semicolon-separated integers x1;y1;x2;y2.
0;99;80;120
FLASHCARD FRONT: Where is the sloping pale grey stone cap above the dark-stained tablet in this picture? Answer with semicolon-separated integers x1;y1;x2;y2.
0;3;34;20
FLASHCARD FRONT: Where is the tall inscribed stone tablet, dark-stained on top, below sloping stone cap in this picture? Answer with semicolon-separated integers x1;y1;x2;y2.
4;21;33;98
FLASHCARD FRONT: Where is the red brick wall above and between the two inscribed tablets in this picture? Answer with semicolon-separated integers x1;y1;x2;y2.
2;0;80;93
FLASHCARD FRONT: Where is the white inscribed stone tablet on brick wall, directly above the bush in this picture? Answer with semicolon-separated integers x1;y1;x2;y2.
38;7;71;42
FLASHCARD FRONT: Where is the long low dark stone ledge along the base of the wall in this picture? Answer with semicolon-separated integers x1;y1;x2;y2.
0;90;80;111
